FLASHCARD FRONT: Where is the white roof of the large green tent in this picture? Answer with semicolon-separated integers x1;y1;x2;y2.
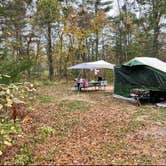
124;57;166;73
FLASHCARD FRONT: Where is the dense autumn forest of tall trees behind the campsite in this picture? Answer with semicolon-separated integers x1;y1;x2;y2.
0;0;166;82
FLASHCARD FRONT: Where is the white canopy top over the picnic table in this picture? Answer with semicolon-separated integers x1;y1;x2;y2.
68;60;115;69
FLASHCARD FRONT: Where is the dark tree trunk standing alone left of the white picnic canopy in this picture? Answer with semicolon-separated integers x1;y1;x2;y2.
47;23;54;81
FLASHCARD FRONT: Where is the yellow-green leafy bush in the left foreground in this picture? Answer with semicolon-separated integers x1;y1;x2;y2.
0;78;35;155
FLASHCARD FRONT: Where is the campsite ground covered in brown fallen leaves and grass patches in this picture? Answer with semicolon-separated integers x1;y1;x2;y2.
0;84;166;165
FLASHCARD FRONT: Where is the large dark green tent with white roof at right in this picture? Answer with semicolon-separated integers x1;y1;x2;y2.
114;57;166;101
